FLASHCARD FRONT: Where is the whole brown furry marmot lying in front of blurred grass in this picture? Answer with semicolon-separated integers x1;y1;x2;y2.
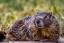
7;12;60;41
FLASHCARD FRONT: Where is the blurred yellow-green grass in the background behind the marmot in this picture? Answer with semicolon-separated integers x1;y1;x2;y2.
0;0;64;31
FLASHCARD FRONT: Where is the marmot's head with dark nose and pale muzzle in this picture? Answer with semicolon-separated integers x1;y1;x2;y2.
34;12;52;28
